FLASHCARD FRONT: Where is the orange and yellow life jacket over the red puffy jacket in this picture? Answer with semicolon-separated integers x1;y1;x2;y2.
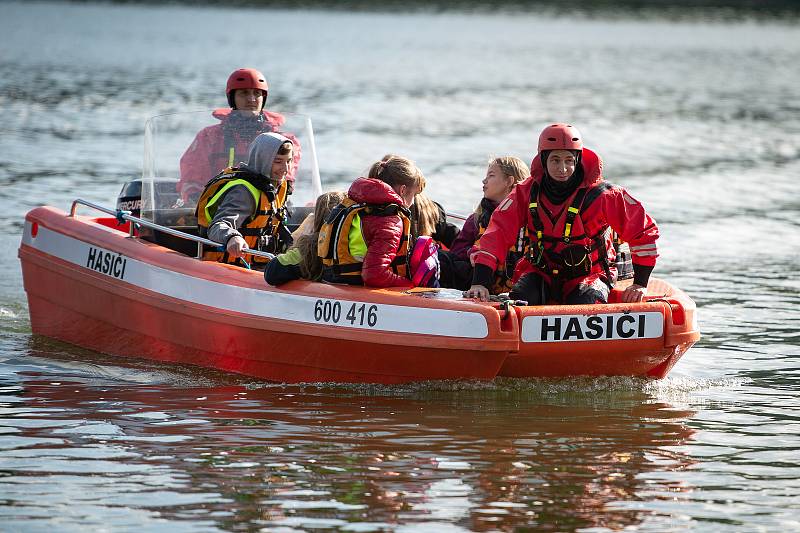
317;198;411;285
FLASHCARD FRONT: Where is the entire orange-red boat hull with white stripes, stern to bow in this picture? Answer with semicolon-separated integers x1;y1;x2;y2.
19;207;699;384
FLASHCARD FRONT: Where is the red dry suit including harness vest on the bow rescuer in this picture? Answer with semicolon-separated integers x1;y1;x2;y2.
470;148;658;295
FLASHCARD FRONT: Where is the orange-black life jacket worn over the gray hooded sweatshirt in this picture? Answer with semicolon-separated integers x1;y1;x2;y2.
195;167;291;265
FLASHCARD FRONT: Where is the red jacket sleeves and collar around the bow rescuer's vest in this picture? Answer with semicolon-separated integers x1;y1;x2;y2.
470;148;658;292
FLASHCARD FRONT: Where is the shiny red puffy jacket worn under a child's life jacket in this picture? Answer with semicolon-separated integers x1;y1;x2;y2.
347;178;413;287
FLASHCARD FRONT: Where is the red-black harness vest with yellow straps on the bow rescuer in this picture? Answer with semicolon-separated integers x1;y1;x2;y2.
525;181;615;286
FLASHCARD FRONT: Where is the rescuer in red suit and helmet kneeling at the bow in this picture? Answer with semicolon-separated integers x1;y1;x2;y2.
465;124;658;305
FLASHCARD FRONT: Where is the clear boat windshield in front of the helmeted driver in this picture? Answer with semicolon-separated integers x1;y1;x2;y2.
141;109;321;226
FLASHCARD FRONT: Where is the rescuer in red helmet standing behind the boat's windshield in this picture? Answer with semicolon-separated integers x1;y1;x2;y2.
177;68;300;203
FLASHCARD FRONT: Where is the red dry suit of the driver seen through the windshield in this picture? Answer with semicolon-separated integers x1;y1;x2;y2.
177;108;300;201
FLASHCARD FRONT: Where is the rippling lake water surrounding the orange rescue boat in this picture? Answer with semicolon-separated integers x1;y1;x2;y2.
0;2;800;532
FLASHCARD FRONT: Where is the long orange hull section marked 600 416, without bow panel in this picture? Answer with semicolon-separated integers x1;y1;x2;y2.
19;208;517;383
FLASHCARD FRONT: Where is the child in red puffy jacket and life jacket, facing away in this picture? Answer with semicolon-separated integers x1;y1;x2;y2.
318;156;425;287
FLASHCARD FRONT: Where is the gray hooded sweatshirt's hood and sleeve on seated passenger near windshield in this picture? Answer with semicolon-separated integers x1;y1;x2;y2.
208;132;291;244
